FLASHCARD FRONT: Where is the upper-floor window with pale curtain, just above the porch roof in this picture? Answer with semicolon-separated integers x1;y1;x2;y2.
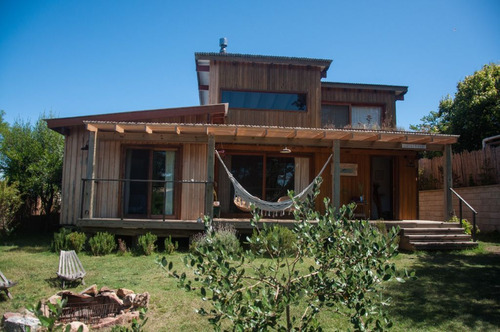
321;105;382;129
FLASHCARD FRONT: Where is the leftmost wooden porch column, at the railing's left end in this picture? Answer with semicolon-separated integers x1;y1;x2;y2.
82;125;97;218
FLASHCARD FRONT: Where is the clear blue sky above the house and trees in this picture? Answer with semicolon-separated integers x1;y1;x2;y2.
0;0;500;128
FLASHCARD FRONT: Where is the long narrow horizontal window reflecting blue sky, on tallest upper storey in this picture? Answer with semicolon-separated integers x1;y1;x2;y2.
222;90;307;111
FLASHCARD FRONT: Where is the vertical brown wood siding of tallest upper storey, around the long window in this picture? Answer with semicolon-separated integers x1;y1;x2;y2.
209;61;321;128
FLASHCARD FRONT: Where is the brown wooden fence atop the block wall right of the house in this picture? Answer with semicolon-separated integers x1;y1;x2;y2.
418;147;500;190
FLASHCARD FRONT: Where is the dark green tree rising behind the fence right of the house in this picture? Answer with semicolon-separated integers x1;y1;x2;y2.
410;64;500;152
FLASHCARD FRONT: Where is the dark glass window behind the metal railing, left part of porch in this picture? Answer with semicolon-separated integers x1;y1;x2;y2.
124;149;175;217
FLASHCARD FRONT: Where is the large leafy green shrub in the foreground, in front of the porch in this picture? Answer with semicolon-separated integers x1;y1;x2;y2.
158;180;410;331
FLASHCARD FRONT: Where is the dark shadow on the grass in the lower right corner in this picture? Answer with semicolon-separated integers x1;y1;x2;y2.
389;252;500;330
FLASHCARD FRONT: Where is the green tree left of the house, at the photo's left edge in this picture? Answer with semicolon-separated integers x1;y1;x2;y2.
0;115;64;219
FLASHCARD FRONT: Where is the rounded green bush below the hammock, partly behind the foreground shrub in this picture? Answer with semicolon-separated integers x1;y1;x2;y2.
249;225;297;256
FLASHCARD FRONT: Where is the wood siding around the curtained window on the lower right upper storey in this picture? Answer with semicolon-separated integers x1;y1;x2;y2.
318;88;396;127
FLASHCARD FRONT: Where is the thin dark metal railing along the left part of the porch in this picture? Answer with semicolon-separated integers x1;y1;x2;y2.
80;178;210;221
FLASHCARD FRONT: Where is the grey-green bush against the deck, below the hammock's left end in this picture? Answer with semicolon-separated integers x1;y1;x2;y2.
189;224;241;255
